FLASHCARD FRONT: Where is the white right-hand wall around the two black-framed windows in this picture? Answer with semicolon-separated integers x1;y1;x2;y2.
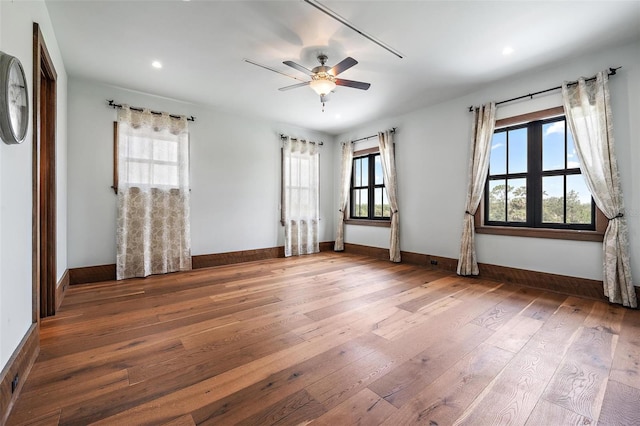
334;42;640;284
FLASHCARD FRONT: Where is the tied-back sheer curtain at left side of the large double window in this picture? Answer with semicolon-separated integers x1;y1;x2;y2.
458;102;496;275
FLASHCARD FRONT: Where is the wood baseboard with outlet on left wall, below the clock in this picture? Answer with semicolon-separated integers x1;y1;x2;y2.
0;323;40;425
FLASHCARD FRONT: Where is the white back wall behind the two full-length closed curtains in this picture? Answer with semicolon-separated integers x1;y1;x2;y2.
68;78;335;268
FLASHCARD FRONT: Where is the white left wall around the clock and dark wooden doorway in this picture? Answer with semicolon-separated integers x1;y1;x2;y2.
0;1;67;368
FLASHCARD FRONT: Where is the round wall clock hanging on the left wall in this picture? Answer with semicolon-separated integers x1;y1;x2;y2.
0;52;29;144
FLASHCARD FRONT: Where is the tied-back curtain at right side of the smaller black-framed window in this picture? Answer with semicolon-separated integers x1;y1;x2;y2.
378;130;401;262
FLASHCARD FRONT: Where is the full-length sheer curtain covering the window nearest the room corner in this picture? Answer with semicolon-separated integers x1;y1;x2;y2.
282;137;320;257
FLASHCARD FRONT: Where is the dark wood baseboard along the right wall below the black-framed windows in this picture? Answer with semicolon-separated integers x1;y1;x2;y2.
344;243;640;301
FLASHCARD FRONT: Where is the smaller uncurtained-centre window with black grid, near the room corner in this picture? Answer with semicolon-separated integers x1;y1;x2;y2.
350;149;391;222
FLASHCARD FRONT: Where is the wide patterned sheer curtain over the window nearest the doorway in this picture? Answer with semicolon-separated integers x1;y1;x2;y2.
116;105;191;279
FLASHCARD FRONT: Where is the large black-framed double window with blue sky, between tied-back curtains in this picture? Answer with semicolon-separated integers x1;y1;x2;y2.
478;109;603;240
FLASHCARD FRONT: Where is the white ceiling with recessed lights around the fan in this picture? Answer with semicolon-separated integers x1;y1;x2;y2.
46;0;640;134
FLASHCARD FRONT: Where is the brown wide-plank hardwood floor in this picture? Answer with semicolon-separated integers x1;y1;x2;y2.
9;252;640;426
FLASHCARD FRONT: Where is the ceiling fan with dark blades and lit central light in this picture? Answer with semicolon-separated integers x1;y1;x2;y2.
245;54;371;111
